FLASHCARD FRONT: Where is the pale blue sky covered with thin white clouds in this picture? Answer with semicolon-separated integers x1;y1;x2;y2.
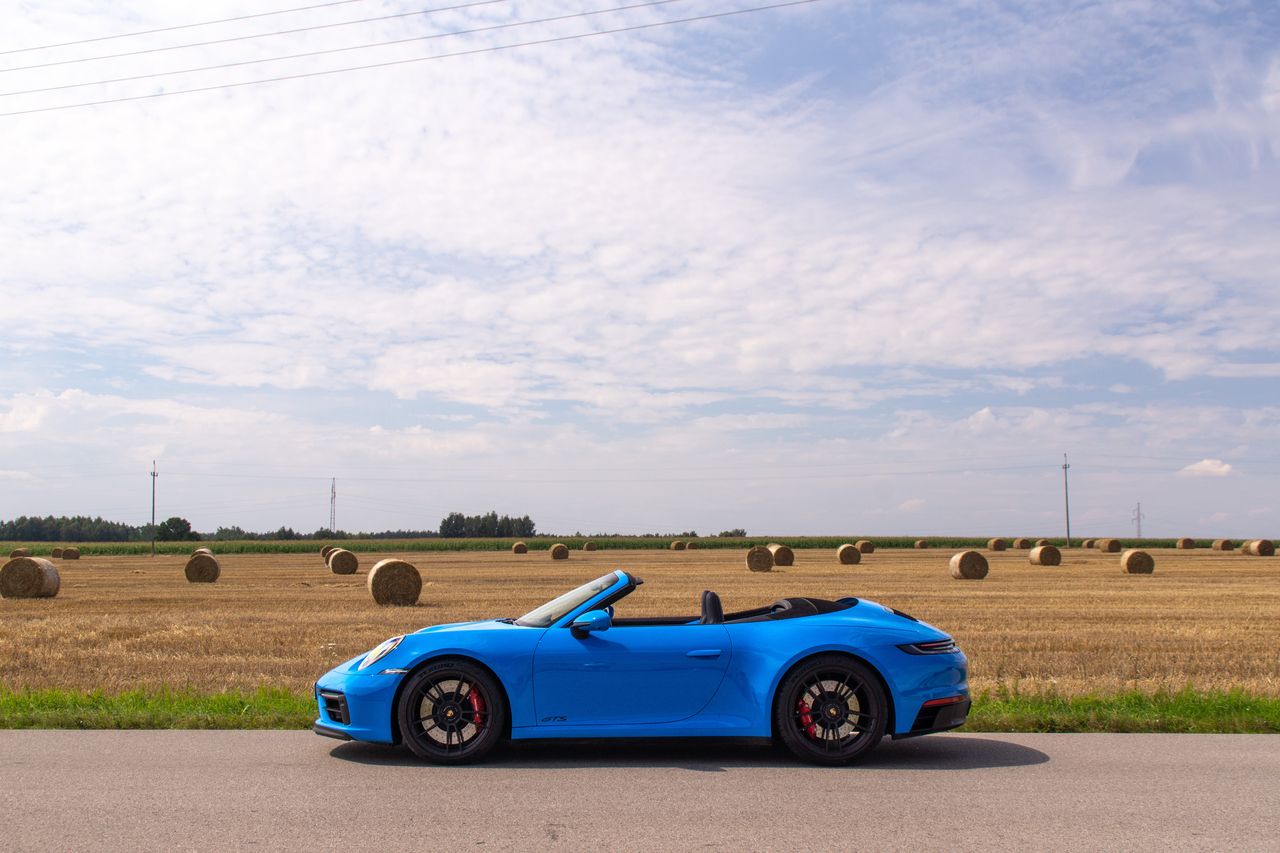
0;0;1280;538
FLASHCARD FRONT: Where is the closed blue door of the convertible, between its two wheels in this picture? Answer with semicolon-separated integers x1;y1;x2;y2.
534;625;732;725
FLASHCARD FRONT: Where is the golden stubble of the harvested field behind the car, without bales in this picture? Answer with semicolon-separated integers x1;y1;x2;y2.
0;548;1280;697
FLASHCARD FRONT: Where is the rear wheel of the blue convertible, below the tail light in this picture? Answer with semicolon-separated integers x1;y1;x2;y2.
773;654;888;765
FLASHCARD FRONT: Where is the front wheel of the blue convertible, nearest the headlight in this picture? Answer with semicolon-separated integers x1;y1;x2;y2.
396;661;508;765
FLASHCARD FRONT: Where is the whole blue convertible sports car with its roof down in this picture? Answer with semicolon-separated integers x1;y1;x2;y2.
315;571;969;765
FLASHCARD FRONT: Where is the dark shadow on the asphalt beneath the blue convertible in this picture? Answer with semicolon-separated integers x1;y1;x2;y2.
329;734;1050;772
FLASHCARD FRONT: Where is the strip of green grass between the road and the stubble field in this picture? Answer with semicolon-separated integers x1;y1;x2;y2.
0;688;1280;734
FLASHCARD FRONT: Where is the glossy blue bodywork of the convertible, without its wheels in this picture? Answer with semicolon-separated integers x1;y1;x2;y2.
316;571;969;743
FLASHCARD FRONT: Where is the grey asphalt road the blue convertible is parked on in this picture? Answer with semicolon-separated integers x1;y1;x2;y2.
0;731;1280;852
